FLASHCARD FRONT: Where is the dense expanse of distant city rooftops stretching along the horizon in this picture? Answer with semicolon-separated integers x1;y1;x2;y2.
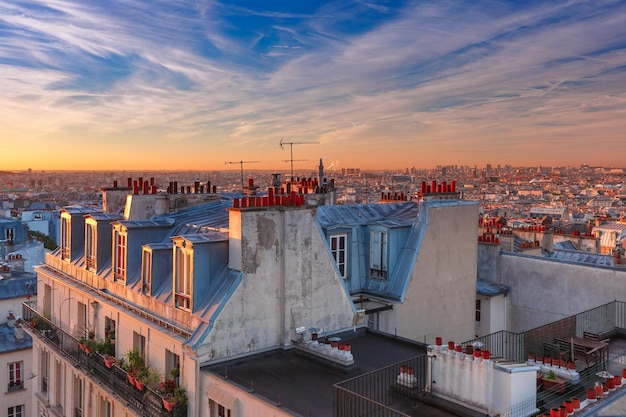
0;165;626;223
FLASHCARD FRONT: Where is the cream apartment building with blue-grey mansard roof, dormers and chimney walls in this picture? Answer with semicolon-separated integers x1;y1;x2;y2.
23;176;478;417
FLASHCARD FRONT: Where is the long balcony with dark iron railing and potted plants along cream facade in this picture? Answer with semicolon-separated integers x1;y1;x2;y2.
22;303;187;417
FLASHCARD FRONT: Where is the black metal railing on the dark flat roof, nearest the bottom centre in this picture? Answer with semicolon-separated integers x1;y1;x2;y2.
333;355;427;417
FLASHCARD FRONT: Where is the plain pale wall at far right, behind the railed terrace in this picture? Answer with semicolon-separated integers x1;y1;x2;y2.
500;253;626;332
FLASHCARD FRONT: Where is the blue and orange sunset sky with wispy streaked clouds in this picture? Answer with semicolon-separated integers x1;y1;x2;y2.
0;0;626;171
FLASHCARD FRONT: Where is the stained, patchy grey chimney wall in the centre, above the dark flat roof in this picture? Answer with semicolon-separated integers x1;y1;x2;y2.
199;207;355;360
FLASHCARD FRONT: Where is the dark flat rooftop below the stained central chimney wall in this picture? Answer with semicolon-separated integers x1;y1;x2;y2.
202;330;460;417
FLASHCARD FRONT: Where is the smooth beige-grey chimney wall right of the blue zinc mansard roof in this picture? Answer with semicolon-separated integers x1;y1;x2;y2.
395;201;478;343
